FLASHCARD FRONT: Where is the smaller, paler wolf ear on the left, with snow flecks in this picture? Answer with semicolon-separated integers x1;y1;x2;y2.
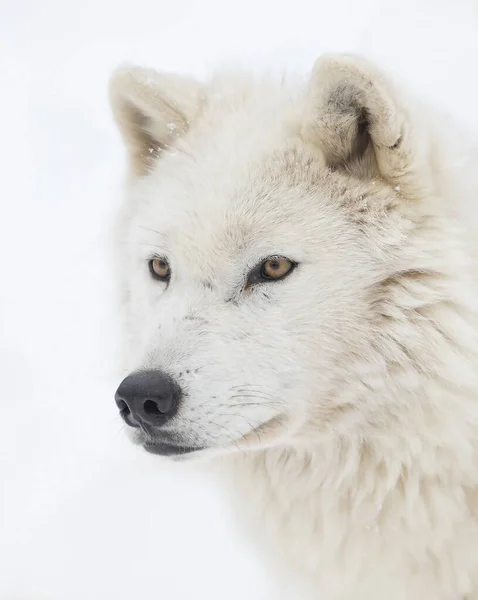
109;67;202;175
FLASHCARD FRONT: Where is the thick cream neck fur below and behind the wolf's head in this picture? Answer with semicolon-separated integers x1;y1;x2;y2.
224;117;478;600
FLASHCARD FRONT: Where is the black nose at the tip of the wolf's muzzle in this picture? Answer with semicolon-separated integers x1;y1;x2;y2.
115;371;181;427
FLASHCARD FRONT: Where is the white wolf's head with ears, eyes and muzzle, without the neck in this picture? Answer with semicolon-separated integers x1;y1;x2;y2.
110;56;444;454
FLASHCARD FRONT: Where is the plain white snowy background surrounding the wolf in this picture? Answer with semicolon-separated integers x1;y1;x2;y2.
0;0;478;600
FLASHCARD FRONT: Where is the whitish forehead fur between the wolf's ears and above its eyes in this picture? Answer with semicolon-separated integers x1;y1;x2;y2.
125;74;395;258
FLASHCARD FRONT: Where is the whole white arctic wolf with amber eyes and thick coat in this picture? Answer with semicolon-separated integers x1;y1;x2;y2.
110;55;478;600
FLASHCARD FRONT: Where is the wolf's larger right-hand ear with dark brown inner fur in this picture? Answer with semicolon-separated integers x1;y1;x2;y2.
303;55;426;192
